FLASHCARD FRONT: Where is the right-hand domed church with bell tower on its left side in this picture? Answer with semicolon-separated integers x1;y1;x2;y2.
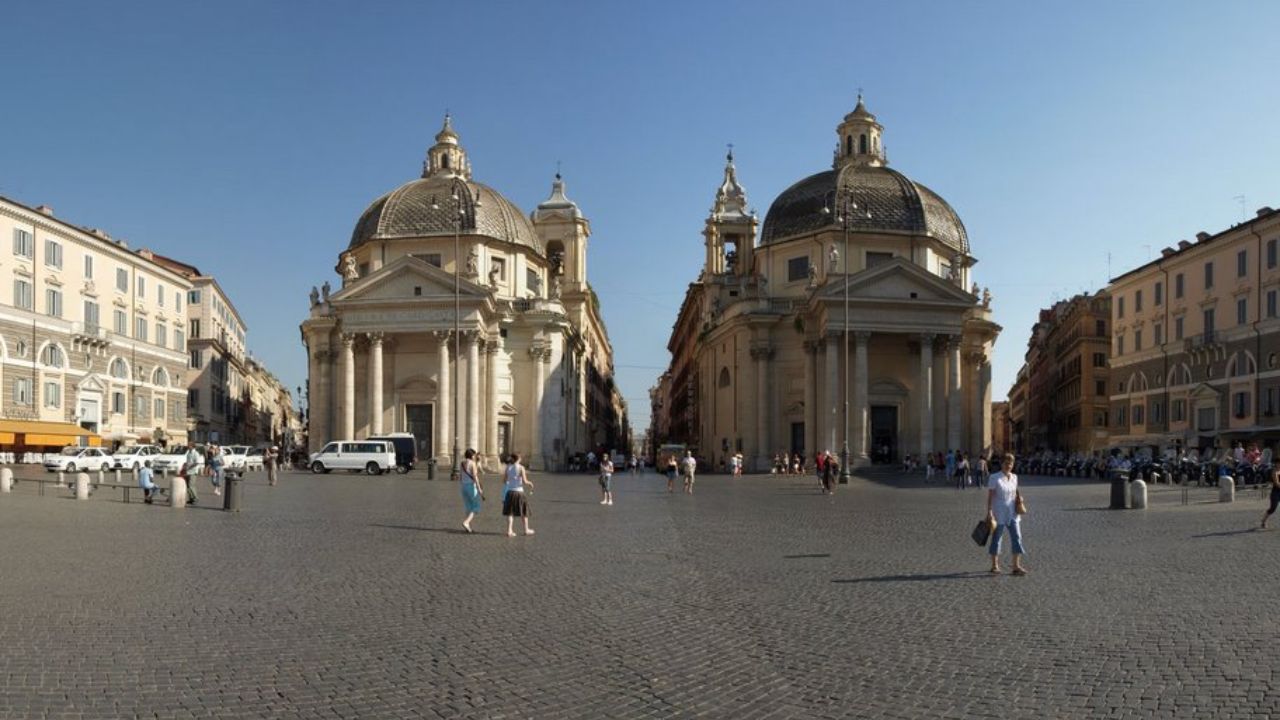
654;95;1000;470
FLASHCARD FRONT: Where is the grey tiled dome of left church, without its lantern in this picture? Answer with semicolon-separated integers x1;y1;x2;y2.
348;174;545;256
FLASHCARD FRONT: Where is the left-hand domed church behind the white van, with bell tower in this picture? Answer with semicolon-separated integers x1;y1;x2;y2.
295;115;627;469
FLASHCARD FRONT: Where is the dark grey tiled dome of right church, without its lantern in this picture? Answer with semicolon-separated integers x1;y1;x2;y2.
760;164;969;255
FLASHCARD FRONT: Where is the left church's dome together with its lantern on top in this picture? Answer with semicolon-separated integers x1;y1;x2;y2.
348;115;545;256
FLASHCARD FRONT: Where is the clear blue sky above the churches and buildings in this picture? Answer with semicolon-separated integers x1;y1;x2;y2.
0;1;1280;427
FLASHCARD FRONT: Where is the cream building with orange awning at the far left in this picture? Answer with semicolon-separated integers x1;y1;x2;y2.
0;197;191;450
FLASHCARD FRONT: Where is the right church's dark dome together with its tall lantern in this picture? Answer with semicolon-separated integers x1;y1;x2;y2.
760;95;969;255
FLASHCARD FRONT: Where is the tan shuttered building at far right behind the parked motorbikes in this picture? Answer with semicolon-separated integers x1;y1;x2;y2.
1107;208;1280;450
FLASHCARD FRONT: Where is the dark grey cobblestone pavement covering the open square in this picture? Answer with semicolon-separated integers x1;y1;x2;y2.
0;461;1280;719
